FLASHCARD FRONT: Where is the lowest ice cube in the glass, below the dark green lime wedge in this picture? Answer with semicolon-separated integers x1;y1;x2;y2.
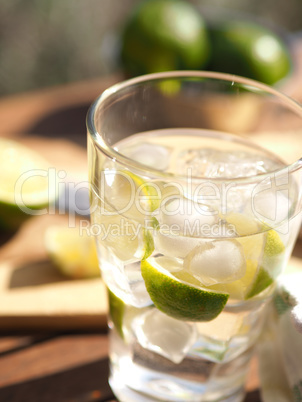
132;308;197;364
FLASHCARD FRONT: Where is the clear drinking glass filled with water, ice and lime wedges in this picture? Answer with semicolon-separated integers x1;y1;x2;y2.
87;71;302;402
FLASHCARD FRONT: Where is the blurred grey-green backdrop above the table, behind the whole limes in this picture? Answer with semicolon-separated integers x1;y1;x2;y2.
0;0;302;96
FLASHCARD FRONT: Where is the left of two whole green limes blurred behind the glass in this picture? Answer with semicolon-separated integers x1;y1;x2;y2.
121;0;209;76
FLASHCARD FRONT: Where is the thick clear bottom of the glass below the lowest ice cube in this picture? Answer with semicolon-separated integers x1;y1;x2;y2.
109;333;253;402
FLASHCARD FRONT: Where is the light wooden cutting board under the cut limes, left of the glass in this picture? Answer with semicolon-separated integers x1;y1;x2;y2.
0;137;107;330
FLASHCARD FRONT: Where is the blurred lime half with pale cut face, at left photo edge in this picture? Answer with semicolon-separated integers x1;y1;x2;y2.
0;138;56;230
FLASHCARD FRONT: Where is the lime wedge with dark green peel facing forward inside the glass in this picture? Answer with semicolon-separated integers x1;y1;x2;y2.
141;258;229;321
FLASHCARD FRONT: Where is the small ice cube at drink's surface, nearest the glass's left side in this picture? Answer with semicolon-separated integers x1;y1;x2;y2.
121;142;171;170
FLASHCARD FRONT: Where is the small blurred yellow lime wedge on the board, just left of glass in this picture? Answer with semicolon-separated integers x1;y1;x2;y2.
45;226;100;279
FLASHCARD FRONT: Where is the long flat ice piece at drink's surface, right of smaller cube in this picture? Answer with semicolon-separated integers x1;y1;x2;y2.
178;148;280;178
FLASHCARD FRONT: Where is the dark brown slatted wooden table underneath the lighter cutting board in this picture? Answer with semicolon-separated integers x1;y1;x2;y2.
0;65;302;402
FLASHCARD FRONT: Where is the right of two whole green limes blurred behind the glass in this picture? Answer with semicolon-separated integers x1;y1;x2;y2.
210;20;291;85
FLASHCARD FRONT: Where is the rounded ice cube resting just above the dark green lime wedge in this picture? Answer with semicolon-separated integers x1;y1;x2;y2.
184;239;246;286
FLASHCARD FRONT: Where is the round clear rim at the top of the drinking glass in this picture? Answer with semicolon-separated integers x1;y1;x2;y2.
86;70;302;183
